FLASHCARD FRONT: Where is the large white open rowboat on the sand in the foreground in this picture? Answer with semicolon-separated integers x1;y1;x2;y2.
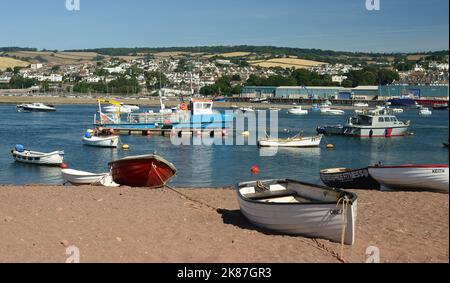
236;180;357;245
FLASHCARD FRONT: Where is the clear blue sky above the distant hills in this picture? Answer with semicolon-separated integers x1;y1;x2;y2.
0;0;449;52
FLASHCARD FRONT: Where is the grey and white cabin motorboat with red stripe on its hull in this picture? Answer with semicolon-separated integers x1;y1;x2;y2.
317;109;410;138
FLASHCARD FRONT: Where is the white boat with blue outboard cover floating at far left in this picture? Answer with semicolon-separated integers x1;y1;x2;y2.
11;144;64;166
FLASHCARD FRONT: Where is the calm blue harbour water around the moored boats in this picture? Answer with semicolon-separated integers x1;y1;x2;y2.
0;105;449;187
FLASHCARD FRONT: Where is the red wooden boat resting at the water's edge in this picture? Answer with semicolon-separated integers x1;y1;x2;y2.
109;154;177;188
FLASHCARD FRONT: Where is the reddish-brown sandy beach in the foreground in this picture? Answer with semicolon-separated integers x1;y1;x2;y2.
0;186;449;263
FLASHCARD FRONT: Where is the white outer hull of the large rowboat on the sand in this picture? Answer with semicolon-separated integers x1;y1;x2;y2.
237;180;357;245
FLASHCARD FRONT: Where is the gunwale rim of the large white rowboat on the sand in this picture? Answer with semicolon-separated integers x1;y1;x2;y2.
235;179;358;206
